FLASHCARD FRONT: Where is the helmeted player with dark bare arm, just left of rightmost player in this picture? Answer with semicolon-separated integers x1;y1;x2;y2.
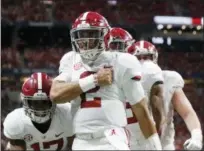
128;40;165;131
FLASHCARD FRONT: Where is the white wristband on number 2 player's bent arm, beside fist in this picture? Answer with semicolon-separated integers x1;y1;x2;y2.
79;74;97;92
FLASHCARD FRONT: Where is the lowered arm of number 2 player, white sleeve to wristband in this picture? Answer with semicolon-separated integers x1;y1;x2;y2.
122;56;161;150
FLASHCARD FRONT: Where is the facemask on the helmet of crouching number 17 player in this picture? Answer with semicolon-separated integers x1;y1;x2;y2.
21;93;56;124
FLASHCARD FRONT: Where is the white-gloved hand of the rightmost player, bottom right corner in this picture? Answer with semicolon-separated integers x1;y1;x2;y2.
183;138;203;150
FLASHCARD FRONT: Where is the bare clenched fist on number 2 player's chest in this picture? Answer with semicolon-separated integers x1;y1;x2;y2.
96;67;113;86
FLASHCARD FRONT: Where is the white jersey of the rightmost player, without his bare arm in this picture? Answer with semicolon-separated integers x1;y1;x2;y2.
161;70;184;150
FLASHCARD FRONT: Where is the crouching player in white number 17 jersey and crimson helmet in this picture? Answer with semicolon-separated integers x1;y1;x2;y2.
4;73;73;151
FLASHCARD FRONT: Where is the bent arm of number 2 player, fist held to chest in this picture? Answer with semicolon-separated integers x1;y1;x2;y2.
50;68;112;103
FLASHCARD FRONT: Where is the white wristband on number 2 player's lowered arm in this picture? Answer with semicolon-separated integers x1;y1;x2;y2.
147;133;162;150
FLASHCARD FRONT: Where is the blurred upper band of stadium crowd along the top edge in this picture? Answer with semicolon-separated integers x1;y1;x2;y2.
2;0;204;24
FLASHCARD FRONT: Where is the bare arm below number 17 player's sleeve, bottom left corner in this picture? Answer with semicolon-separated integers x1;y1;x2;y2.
6;139;26;151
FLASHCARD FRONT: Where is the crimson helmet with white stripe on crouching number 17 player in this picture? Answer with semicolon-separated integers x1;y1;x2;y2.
21;72;56;123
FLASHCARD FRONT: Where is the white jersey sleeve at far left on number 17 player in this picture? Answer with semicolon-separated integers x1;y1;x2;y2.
3;109;24;139
